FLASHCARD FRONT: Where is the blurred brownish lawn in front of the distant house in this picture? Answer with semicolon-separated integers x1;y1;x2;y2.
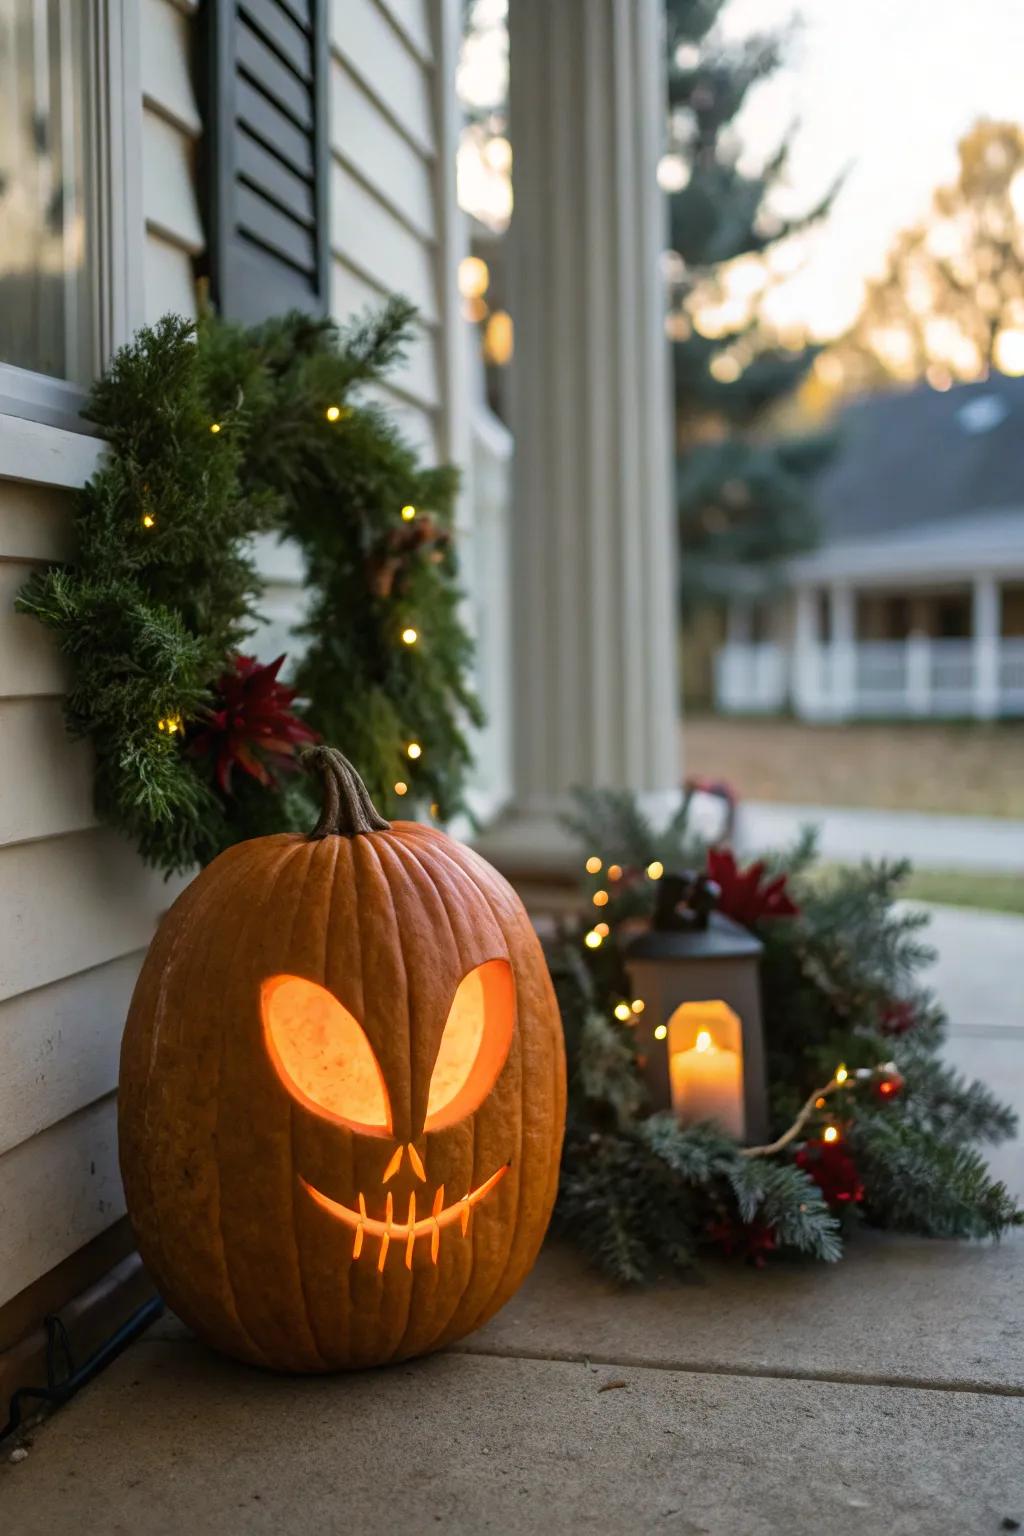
683;716;1024;817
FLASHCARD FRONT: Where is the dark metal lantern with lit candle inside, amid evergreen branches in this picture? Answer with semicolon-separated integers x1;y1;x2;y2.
626;874;768;1143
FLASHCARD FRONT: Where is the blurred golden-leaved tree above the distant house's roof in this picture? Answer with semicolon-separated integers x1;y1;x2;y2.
823;121;1024;392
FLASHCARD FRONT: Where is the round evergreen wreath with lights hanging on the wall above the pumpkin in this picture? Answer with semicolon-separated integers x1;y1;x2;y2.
18;300;481;874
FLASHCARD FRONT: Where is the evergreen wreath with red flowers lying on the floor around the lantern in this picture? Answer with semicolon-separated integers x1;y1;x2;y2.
551;793;1024;1283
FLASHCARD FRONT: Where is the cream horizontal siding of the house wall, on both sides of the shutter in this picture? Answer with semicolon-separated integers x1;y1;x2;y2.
0;0;482;1307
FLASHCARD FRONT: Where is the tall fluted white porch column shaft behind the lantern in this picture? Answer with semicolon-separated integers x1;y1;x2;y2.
508;0;682;816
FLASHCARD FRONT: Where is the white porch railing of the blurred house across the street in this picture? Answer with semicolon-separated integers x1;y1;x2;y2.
715;634;1024;720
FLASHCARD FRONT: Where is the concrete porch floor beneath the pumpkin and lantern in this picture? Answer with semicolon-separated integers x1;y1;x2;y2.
0;909;1024;1536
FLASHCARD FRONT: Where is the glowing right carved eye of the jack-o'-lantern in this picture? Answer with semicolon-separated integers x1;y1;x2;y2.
424;960;516;1130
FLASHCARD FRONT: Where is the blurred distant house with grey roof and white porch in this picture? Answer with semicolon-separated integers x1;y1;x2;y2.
715;375;1024;720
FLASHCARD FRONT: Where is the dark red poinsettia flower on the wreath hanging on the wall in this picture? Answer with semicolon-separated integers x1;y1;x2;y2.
190;656;319;794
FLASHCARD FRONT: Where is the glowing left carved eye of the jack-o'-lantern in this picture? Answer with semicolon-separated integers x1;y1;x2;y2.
263;975;391;1137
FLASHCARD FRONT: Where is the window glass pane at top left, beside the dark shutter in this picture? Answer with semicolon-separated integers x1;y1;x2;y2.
0;0;94;382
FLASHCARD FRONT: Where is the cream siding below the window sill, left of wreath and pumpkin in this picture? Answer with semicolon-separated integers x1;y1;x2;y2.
0;457;191;1306
